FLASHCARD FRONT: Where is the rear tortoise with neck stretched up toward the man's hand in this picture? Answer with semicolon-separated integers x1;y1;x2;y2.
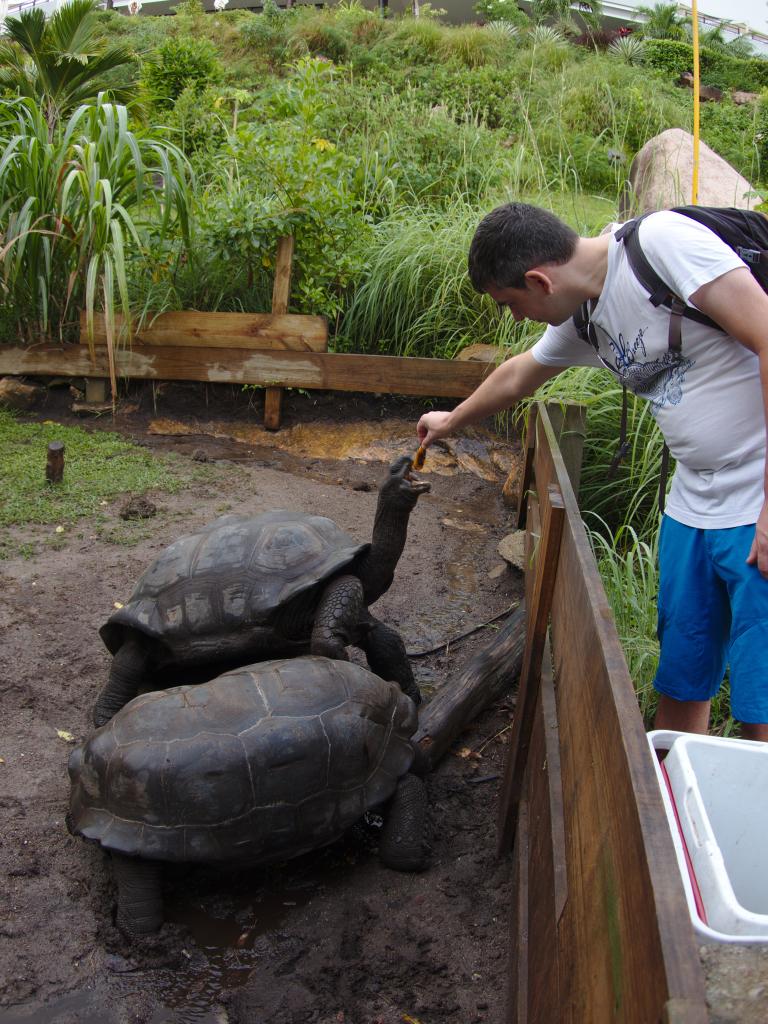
93;456;429;726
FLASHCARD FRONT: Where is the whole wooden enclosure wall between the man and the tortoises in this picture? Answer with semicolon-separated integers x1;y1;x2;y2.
500;406;709;1024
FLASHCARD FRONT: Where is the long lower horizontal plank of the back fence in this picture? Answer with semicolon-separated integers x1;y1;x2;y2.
0;345;493;398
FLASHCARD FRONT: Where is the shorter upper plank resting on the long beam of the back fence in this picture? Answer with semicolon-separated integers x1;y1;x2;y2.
80;310;328;352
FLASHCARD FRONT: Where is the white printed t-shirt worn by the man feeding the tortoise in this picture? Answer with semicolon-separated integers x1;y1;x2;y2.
531;210;768;528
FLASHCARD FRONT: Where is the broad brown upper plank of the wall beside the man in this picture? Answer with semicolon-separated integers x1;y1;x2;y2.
528;408;708;1024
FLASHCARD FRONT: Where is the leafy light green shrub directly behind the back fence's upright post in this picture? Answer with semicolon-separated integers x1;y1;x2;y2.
194;57;385;318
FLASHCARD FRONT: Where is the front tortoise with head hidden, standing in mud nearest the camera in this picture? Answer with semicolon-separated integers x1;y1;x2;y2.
68;656;429;935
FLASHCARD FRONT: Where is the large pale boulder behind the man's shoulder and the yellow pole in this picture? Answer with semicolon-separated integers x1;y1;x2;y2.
622;128;763;218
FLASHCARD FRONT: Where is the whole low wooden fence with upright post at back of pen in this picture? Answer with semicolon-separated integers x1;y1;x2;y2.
0;236;494;429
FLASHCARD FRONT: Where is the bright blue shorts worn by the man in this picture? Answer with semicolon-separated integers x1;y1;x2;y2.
653;516;768;722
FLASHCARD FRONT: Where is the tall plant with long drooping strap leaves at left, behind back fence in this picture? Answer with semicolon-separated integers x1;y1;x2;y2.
0;98;187;392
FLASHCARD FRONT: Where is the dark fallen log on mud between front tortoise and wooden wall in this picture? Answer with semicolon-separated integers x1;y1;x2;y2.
414;604;525;774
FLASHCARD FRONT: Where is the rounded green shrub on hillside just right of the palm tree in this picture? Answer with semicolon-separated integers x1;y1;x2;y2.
142;37;223;110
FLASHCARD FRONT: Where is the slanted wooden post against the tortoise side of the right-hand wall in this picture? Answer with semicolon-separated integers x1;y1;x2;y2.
497;483;565;856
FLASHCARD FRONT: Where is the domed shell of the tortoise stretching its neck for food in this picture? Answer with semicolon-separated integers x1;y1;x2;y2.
99;509;371;659
